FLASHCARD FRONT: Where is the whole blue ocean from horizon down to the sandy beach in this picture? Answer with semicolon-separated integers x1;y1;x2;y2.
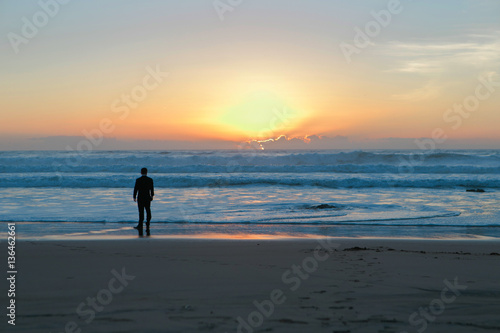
0;150;500;239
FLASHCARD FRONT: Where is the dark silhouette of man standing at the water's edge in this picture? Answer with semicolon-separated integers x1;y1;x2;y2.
134;168;155;236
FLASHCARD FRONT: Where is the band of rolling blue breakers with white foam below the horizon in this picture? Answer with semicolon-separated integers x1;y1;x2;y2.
0;150;500;188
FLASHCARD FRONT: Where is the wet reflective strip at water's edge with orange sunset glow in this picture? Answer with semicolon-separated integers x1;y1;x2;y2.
5;222;500;241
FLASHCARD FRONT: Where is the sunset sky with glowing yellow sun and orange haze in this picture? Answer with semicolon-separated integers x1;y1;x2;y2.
0;0;500;149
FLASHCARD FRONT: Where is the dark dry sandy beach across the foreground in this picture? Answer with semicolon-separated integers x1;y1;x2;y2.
7;238;500;333
